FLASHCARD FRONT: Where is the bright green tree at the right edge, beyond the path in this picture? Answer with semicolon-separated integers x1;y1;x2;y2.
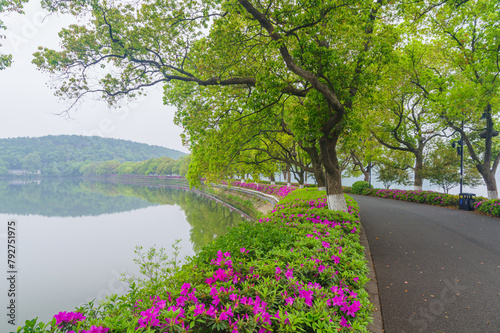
404;0;500;199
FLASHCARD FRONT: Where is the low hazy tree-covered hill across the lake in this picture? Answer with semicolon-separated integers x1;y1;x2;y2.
0;135;186;176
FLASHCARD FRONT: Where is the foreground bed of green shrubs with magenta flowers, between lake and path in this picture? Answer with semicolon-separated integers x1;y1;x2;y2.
18;189;371;333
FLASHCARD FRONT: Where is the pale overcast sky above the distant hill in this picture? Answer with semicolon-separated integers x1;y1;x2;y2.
0;1;189;152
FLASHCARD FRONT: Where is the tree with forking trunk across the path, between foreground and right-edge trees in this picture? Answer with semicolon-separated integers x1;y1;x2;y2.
367;45;447;190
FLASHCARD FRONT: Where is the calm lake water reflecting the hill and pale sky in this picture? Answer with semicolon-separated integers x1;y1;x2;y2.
0;180;249;332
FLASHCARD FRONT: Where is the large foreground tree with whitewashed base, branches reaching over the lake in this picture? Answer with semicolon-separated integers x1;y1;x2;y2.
34;0;395;210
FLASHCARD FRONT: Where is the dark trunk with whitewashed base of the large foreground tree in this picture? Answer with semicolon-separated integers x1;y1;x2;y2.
319;134;347;212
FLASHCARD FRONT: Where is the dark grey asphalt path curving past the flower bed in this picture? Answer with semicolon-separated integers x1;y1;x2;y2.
353;195;500;333
